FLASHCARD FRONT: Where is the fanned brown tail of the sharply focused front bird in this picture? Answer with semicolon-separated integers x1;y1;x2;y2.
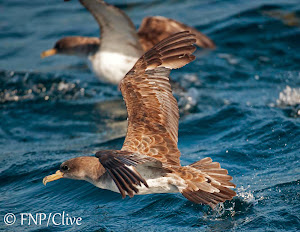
181;157;236;208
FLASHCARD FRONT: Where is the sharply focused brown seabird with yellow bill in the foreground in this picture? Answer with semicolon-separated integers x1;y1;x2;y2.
43;31;236;208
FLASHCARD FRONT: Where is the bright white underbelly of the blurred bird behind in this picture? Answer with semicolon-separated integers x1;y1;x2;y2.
90;51;138;84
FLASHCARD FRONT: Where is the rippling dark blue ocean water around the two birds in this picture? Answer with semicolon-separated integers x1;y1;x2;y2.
0;0;300;231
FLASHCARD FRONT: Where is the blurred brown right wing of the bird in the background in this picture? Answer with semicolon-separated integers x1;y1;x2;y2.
138;16;215;51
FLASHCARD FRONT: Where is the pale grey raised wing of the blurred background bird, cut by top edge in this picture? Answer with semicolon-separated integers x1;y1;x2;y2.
80;0;143;57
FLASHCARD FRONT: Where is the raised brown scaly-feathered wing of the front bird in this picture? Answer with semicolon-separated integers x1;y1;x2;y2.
120;31;196;165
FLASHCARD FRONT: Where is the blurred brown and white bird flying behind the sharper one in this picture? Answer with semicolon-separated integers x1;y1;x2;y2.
41;0;215;84
